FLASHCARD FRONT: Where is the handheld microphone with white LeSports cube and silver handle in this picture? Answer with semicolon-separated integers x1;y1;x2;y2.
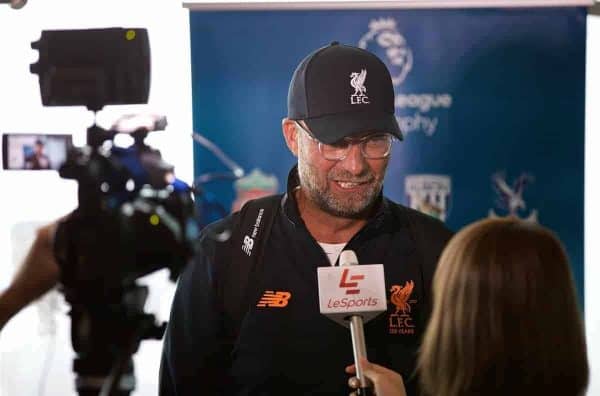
317;250;387;396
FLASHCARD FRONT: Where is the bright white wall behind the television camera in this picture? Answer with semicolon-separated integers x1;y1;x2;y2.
0;0;193;396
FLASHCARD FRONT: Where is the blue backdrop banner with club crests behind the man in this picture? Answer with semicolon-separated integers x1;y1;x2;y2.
190;8;586;304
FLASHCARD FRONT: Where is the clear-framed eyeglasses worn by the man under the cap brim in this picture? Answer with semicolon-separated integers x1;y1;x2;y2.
295;121;394;161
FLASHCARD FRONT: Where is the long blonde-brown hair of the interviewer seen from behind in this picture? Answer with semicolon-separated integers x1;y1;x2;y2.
418;218;588;396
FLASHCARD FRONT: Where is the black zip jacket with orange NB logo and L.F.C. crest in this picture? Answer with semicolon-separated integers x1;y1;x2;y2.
159;169;452;396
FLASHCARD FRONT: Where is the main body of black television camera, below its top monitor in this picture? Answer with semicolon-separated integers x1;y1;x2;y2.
55;127;197;301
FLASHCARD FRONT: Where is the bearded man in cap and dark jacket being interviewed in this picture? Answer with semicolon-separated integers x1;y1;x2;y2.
160;43;451;396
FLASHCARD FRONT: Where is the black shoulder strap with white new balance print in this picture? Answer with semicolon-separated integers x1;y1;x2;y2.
223;195;282;328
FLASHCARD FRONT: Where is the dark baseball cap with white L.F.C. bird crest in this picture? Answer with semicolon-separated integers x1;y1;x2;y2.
288;41;402;144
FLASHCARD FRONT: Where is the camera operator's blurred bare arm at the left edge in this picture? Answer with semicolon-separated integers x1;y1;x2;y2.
0;222;59;330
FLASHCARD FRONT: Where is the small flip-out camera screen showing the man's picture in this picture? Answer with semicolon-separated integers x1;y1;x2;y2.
2;133;72;170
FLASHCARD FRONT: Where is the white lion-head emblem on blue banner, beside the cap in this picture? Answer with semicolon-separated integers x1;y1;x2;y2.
358;18;413;85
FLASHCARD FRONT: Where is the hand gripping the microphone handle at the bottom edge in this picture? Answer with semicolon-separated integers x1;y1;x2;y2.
346;358;406;396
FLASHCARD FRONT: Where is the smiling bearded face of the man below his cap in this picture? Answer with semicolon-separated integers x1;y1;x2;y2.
297;128;389;218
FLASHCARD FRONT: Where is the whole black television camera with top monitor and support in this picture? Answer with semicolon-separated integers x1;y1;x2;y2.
31;28;198;395
